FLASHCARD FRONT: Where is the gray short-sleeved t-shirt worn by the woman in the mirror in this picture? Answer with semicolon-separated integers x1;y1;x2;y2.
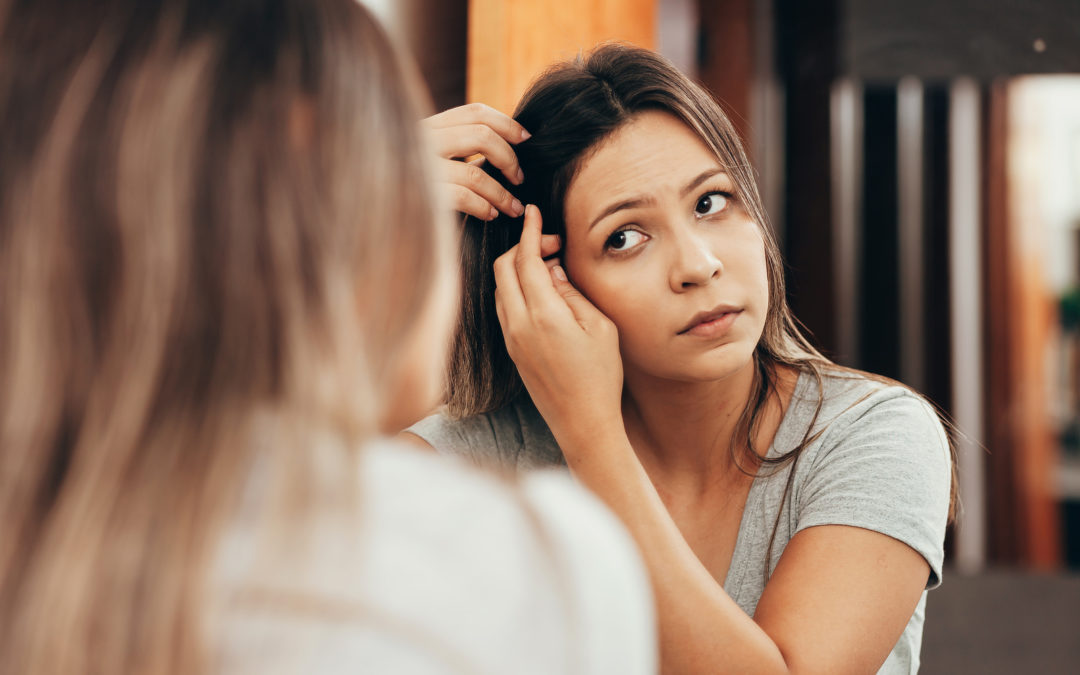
409;373;951;675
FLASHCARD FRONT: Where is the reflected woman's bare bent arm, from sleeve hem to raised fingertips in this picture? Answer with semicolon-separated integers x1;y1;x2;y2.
496;207;929;673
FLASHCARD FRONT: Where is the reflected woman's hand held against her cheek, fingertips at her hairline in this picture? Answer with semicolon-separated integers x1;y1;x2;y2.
495;199;624;453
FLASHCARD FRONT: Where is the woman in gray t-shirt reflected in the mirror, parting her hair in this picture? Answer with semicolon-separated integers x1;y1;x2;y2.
411;45;951;673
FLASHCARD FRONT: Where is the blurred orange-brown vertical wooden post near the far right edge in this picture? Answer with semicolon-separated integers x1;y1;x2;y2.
987;79;1061;569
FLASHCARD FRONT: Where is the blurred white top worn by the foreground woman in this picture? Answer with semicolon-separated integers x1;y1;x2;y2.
208;434;658;675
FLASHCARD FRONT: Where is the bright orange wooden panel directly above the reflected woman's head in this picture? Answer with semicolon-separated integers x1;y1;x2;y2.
465;0;657;113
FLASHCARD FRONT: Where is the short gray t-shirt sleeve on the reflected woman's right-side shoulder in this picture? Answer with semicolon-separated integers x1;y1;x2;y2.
796;390;951;589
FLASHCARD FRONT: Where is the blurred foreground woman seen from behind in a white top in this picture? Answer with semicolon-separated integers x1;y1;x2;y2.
0;0;654;674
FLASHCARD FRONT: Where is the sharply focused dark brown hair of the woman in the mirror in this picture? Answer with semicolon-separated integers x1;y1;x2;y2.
447;43;955;531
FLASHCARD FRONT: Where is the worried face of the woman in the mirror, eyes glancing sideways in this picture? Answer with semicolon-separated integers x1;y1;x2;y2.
564;111;769;381
